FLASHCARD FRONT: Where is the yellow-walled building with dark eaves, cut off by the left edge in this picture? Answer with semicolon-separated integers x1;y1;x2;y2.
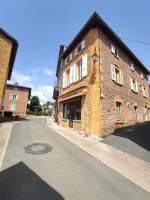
0;28;18;115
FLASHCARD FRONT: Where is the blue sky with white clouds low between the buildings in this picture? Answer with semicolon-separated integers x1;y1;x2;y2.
0;0;150;103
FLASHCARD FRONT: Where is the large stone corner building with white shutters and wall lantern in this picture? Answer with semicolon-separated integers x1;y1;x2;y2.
53;13;150;136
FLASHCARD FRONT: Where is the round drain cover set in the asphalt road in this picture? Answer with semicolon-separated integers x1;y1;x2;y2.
24;143;53;155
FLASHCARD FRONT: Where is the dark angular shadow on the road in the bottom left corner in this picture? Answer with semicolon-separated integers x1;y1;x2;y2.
0;162;64;200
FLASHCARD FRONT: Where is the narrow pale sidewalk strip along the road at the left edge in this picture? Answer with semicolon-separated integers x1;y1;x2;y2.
0;123;13;170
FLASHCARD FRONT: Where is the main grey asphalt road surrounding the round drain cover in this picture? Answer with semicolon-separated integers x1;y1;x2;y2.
0;119;150;200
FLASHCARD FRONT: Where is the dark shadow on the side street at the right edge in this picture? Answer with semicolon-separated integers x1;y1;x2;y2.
113;121;150;151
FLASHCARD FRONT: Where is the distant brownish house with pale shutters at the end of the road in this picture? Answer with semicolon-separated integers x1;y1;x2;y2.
3;84;31;116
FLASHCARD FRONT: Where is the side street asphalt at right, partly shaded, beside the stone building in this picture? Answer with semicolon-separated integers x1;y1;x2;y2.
104;121;150;162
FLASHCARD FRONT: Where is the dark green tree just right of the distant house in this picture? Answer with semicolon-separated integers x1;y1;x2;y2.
29;96;42;112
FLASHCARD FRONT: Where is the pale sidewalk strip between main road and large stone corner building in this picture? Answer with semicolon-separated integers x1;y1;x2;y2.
47;118;150;192
